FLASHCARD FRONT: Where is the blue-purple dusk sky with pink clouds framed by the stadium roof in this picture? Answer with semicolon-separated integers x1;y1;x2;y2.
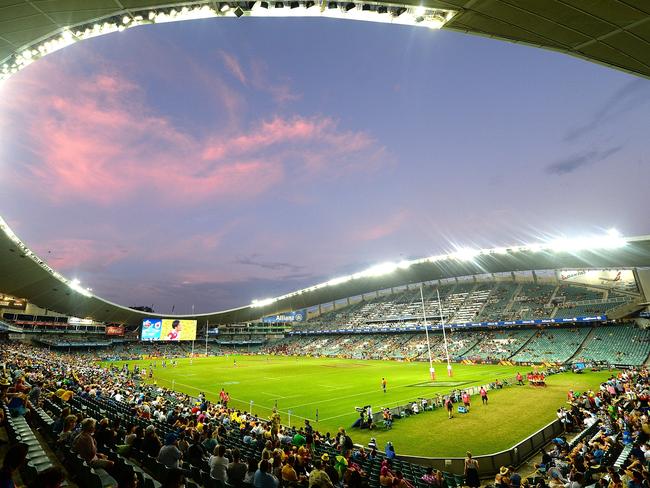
0;18;650;313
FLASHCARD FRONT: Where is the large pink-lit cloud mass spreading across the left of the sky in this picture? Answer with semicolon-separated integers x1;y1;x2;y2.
2;55;384;206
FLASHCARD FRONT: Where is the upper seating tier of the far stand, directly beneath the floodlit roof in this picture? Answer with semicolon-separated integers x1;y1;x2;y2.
304;281;633;330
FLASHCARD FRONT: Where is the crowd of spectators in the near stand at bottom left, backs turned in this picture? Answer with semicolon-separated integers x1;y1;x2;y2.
0;343;410;488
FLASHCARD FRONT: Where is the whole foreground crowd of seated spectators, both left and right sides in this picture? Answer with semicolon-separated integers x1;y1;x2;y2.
0;343;650;488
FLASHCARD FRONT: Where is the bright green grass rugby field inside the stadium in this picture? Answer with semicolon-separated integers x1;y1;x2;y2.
102;356;610;456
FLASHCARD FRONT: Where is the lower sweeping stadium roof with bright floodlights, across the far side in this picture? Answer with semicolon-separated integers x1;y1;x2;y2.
0;218;650;325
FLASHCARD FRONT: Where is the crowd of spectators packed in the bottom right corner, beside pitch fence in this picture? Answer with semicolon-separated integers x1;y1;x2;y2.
524;369;650;488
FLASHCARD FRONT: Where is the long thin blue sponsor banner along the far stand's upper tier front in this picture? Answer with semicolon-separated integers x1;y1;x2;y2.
289;315;607;335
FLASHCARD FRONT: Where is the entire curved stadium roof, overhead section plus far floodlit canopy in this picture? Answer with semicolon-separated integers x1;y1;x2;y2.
0;0;650;324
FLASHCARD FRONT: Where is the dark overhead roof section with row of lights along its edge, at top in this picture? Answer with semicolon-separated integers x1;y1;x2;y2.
0;0;650;78
